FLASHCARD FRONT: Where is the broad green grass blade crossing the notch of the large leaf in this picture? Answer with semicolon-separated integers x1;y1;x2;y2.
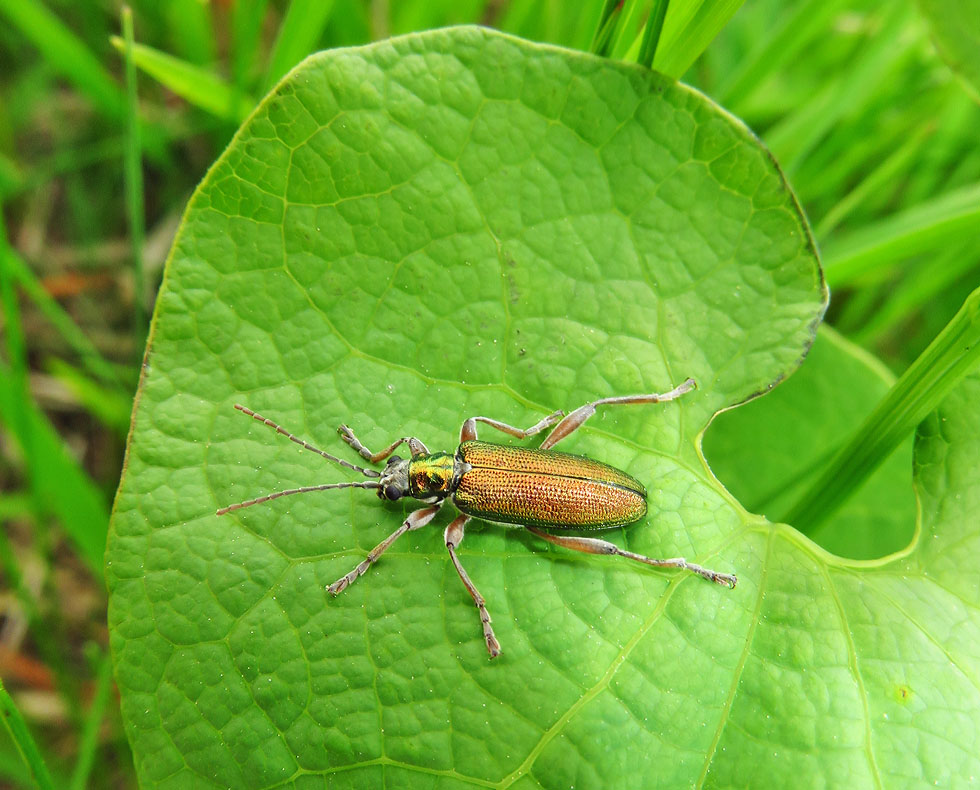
782;288;980;533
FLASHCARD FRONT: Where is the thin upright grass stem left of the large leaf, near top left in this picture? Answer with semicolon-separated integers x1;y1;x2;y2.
122;6;146;355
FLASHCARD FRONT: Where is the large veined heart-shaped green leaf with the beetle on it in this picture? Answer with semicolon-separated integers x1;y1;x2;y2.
107;28;980;788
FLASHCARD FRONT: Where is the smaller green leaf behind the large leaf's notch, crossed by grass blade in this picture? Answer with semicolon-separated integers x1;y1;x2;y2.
704;326;915;559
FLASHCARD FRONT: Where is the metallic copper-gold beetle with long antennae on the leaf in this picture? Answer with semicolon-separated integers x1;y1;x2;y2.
217;378;736;658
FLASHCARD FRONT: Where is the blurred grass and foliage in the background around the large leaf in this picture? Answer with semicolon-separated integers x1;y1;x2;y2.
0;0;980;788
